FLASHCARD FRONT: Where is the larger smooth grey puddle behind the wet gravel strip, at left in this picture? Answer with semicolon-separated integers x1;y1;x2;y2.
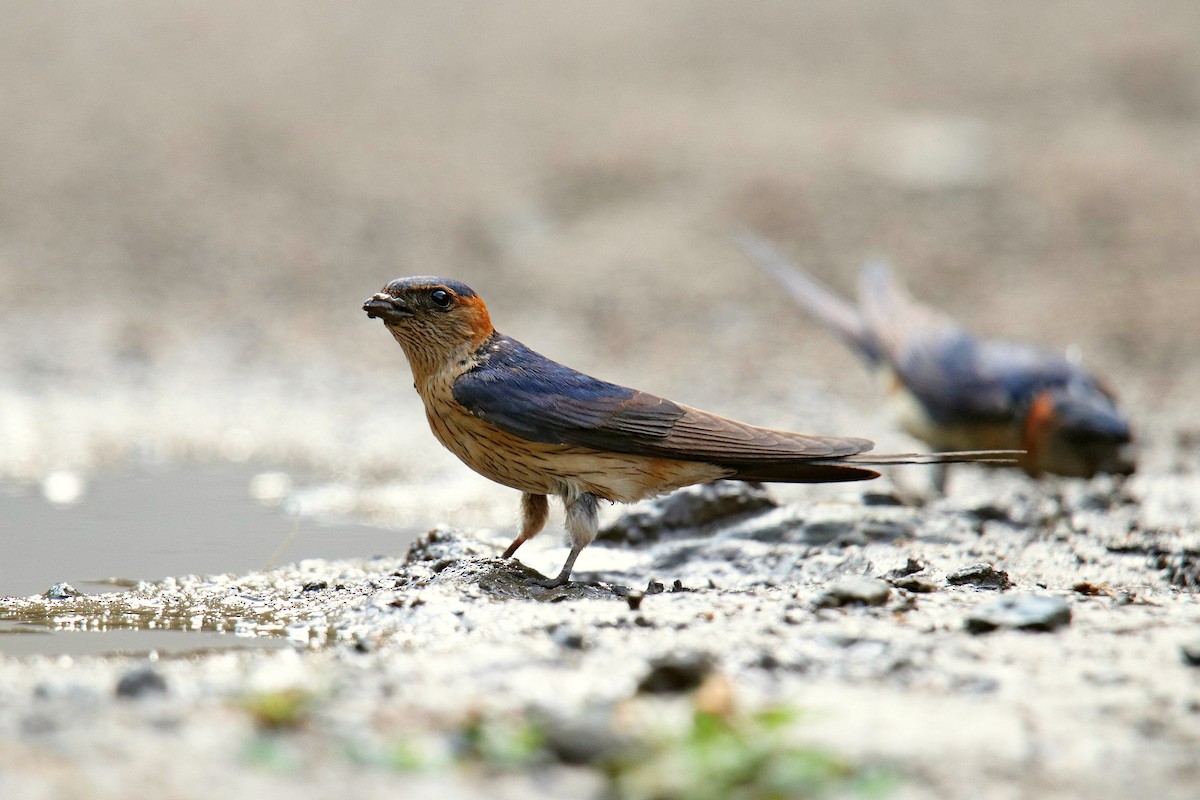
0;465;413;597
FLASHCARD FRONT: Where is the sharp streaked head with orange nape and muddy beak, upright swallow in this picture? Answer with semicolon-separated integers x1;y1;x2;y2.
362;275;494;368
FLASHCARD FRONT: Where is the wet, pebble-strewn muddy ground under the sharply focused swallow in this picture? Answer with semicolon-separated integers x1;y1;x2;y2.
0;477;1200;798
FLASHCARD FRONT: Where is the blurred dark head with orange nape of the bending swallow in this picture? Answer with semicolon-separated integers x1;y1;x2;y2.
1025;381;1136;477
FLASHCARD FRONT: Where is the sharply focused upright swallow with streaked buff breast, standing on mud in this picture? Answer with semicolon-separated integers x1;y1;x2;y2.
362;276;1012;587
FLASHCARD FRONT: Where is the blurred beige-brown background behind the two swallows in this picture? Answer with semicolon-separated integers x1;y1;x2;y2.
0;0;1200;594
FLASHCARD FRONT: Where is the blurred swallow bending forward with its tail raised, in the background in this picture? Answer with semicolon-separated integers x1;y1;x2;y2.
737;233;1134;483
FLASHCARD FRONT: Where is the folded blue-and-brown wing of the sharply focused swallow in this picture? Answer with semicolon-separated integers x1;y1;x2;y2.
454;337;872;465
